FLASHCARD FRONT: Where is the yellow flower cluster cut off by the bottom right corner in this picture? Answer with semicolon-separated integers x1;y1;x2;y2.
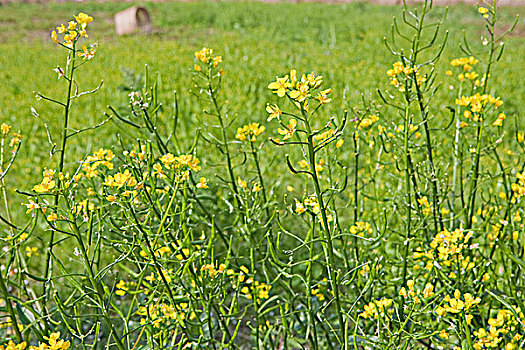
473;306;525;350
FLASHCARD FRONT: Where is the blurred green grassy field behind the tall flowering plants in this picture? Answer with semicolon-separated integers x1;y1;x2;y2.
0;2;525;202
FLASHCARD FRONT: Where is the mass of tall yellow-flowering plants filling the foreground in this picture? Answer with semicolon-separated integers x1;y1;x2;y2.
0;0;525;350
